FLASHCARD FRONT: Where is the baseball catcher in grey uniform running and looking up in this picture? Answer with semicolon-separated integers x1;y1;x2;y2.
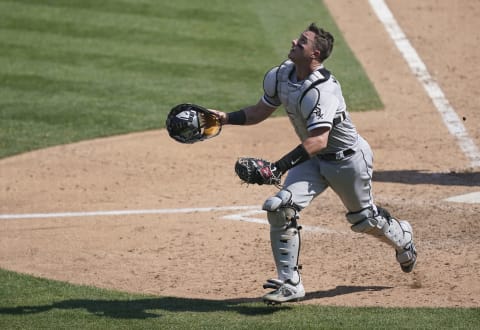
204;23;417;304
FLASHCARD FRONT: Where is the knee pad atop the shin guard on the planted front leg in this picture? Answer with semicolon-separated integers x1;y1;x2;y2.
262;190;297;228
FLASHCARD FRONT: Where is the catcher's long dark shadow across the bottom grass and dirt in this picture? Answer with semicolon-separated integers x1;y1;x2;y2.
0;286;391;319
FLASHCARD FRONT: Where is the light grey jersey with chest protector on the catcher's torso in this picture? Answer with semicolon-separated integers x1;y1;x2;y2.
262;60;358;154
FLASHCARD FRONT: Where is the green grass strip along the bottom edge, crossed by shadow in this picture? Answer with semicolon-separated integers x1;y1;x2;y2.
0;270;480;329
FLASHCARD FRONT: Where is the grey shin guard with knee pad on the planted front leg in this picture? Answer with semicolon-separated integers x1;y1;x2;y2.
263;190;300;284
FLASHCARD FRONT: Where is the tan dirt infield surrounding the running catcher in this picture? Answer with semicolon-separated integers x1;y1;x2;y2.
0;0;480;307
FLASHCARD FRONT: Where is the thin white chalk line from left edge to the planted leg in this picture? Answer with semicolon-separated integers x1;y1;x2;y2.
0;206;259;220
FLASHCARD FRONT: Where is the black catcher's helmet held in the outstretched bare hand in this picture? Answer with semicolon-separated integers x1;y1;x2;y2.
165;103;222;143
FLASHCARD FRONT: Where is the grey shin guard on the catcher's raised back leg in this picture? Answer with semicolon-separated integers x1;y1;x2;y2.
347;207;413;251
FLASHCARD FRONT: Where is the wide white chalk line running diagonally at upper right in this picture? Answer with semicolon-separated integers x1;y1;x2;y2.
369;0;480;167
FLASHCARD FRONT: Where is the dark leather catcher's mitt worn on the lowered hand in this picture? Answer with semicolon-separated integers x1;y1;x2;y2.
235;157;282;185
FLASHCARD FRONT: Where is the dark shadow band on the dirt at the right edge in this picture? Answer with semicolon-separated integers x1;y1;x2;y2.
373;170;480;187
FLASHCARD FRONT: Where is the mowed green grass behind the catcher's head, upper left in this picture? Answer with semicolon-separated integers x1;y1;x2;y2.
0;0;382;158
